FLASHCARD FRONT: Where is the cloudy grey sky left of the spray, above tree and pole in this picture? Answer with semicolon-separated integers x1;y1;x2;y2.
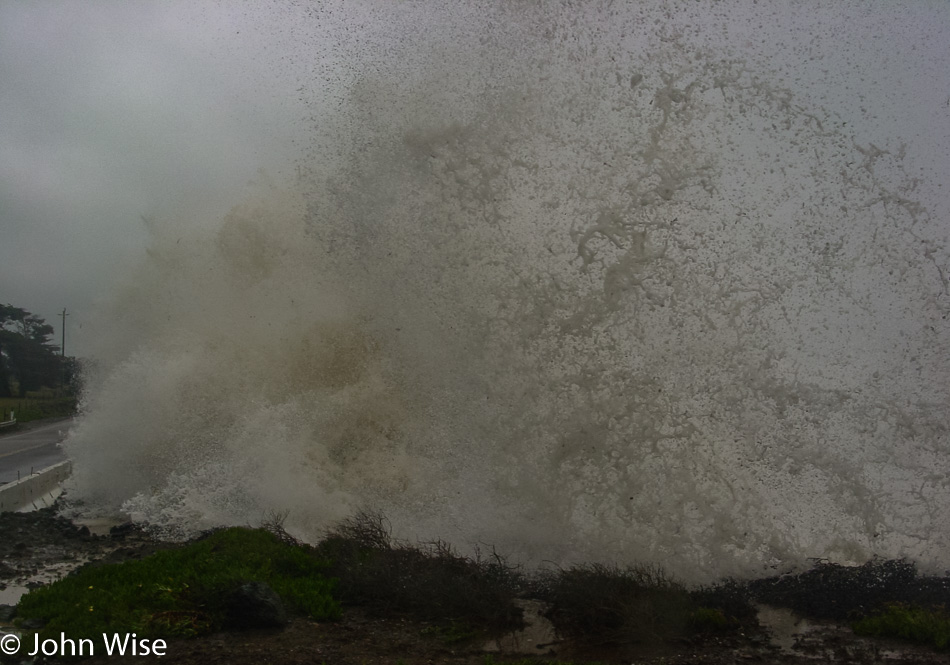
0;0;318;353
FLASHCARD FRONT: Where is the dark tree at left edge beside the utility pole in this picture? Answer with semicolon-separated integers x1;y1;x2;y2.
0;305;63;397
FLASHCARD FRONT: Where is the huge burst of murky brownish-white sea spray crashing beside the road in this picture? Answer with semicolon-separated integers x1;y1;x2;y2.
67;3;950;580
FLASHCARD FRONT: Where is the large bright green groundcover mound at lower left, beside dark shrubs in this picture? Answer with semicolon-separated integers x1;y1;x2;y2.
17;527;340;639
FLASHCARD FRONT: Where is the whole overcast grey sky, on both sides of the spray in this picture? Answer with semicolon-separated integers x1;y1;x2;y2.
0;0;950;355
